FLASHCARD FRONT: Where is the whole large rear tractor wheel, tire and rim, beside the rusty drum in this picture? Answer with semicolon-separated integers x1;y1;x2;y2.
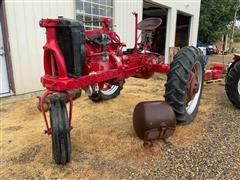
165;46;204;124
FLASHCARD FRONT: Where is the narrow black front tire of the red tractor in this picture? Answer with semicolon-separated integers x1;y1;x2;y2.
50;96;71;165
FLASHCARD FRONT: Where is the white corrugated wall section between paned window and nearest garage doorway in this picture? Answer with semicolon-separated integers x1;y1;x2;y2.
113;0;143;48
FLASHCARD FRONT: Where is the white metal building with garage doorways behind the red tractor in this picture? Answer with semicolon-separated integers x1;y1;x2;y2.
0;0;201;97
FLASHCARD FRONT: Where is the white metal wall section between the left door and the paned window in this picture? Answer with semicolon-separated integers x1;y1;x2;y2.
5;1;75;94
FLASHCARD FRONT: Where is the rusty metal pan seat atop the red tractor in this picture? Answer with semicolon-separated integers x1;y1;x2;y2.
138;18;162;31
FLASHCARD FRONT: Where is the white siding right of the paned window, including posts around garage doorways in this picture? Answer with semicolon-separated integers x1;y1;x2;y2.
114;0;201;63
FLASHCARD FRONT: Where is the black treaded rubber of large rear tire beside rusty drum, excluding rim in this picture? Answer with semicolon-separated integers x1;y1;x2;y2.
164;46;203;124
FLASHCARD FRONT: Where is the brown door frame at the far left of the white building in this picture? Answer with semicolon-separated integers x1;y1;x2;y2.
0;0;15;95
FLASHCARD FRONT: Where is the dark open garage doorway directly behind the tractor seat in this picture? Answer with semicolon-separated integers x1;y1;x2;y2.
143;1;168;55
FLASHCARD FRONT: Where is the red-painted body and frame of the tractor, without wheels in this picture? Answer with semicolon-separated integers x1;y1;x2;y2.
39;13;170;134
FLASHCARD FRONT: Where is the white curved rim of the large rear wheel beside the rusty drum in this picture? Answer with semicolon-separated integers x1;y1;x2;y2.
186;62;203;115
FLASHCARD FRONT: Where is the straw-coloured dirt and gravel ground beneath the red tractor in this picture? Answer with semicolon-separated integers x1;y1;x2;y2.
0;54;240;179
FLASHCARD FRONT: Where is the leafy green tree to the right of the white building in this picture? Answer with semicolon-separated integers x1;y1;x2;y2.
198;0;239;43
